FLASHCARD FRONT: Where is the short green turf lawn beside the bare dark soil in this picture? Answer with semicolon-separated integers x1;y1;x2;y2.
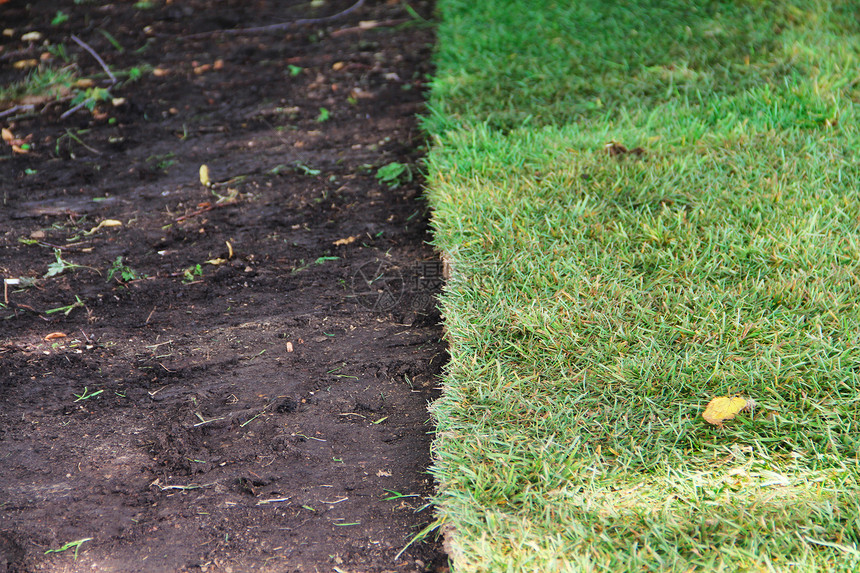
427;0;860;572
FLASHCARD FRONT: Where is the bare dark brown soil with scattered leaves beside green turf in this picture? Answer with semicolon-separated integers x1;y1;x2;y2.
0;0;447;573
